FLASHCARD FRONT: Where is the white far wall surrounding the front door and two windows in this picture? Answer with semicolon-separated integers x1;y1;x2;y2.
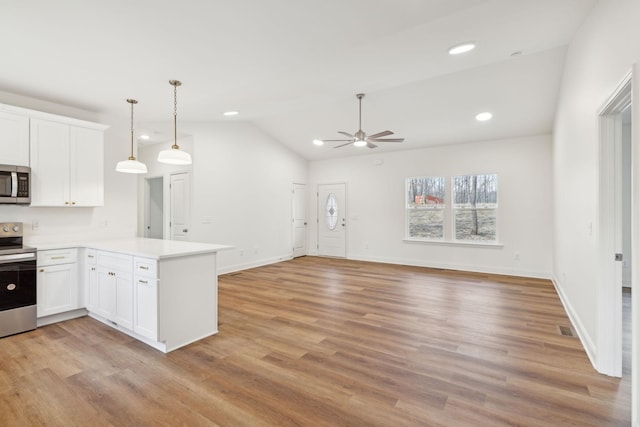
309;135;552;277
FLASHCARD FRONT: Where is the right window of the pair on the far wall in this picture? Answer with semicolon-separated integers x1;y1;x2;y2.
453;174;498;242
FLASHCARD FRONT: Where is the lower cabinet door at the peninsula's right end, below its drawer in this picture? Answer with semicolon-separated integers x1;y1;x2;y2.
133;276;158;341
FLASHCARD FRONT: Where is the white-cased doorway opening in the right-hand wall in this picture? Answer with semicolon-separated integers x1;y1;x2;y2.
596;73;633;377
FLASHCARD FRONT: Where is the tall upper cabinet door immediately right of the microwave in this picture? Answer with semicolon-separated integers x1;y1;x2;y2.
31;119;71;206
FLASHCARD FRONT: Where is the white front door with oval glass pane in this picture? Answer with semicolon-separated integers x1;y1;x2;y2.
318;183;347;258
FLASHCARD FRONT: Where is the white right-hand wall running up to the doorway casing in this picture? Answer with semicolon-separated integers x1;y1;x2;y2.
553;0;640;362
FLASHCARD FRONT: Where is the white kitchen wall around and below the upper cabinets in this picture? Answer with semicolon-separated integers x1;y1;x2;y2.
0;92;136;243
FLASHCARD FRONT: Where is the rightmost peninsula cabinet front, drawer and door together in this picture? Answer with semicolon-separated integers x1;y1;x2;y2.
133;257;158;341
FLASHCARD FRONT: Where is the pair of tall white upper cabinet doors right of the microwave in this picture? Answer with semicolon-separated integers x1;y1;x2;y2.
30;119;104;206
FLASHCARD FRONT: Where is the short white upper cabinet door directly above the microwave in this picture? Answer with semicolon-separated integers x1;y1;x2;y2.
0;112;29;166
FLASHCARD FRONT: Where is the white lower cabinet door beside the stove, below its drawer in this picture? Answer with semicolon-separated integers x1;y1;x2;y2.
37;263;79;317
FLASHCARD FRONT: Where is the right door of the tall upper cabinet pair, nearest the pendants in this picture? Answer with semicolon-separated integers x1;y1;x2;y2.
70;127;104;206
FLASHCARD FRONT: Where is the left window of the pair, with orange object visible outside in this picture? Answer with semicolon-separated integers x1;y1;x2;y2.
406;177;445;240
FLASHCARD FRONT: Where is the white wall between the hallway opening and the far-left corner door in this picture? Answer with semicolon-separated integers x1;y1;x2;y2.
140;122;307;272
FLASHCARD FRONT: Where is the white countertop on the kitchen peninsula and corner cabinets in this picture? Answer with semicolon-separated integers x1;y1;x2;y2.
26;237;232;259
